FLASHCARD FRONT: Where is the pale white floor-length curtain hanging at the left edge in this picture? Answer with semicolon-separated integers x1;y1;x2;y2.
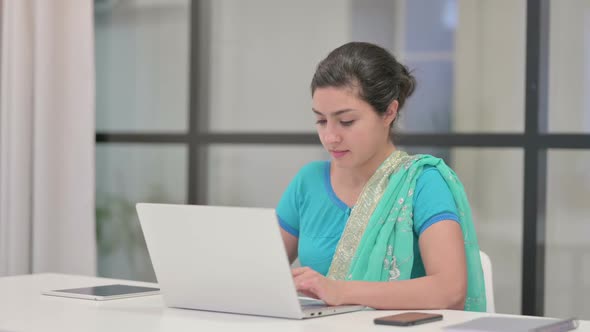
0;0;96;276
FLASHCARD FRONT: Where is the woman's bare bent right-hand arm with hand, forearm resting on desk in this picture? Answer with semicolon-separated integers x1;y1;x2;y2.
293;220;467;309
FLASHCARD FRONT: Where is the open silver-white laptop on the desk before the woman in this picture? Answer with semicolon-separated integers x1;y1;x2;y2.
136;203;366;319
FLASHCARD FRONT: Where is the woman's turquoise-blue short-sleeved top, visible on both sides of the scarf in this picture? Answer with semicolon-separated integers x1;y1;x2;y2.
276;161;459;277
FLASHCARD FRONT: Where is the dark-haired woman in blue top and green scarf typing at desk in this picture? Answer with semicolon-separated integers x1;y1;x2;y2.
277;42;485;311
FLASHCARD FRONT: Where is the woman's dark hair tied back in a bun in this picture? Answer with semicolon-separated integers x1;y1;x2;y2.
311;42;416;122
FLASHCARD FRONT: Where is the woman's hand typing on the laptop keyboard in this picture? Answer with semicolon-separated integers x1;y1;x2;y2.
291;267;344;305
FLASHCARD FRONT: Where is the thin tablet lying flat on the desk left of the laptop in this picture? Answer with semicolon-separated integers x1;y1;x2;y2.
42;284;160;301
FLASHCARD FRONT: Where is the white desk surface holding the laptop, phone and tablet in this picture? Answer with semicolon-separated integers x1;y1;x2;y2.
0;274;590;332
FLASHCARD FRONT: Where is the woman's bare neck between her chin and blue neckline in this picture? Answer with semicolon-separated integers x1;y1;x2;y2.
331;143;396;188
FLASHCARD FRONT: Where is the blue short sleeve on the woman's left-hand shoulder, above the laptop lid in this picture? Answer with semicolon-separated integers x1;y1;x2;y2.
276;172;301;237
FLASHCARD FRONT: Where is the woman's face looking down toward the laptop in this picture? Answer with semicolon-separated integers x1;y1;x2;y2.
313;87;395;168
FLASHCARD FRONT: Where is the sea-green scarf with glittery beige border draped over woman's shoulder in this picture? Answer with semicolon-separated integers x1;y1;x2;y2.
328;150;486;311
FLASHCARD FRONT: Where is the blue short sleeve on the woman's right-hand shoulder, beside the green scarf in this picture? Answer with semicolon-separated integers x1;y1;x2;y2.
414;166;459;235
